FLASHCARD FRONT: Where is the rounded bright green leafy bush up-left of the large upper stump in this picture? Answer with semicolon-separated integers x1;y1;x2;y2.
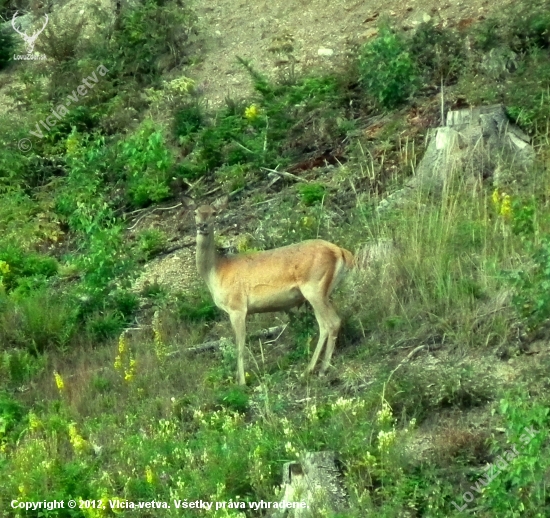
359;26;416;109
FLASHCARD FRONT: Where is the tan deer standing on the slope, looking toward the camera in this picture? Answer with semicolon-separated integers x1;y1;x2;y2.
195;205;355;385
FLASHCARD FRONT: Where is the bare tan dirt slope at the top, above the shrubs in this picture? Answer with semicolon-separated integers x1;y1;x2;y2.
192;0;511;106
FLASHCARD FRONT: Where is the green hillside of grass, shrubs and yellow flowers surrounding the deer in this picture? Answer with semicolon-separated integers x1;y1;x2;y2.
0;0;550;518
